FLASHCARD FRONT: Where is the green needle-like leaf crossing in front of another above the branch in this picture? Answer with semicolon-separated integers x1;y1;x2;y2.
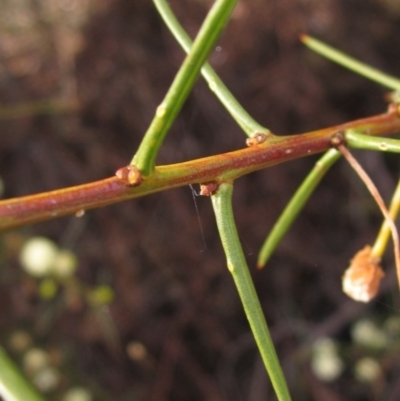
131;0;237;177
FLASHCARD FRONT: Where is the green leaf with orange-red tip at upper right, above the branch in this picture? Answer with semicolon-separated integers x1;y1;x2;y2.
301;35;400;91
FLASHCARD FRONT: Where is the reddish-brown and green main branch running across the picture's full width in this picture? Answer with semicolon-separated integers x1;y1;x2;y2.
0;105;400;230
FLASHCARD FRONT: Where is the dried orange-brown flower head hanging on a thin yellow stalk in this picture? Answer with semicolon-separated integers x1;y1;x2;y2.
342;245;385;302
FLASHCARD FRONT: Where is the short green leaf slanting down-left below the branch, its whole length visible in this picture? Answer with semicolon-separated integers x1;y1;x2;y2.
257;149;340;269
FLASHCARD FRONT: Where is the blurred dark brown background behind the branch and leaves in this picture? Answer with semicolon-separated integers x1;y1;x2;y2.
0;0;400;401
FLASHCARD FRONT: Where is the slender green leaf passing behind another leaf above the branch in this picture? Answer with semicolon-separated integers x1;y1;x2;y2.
154;0;270;136
